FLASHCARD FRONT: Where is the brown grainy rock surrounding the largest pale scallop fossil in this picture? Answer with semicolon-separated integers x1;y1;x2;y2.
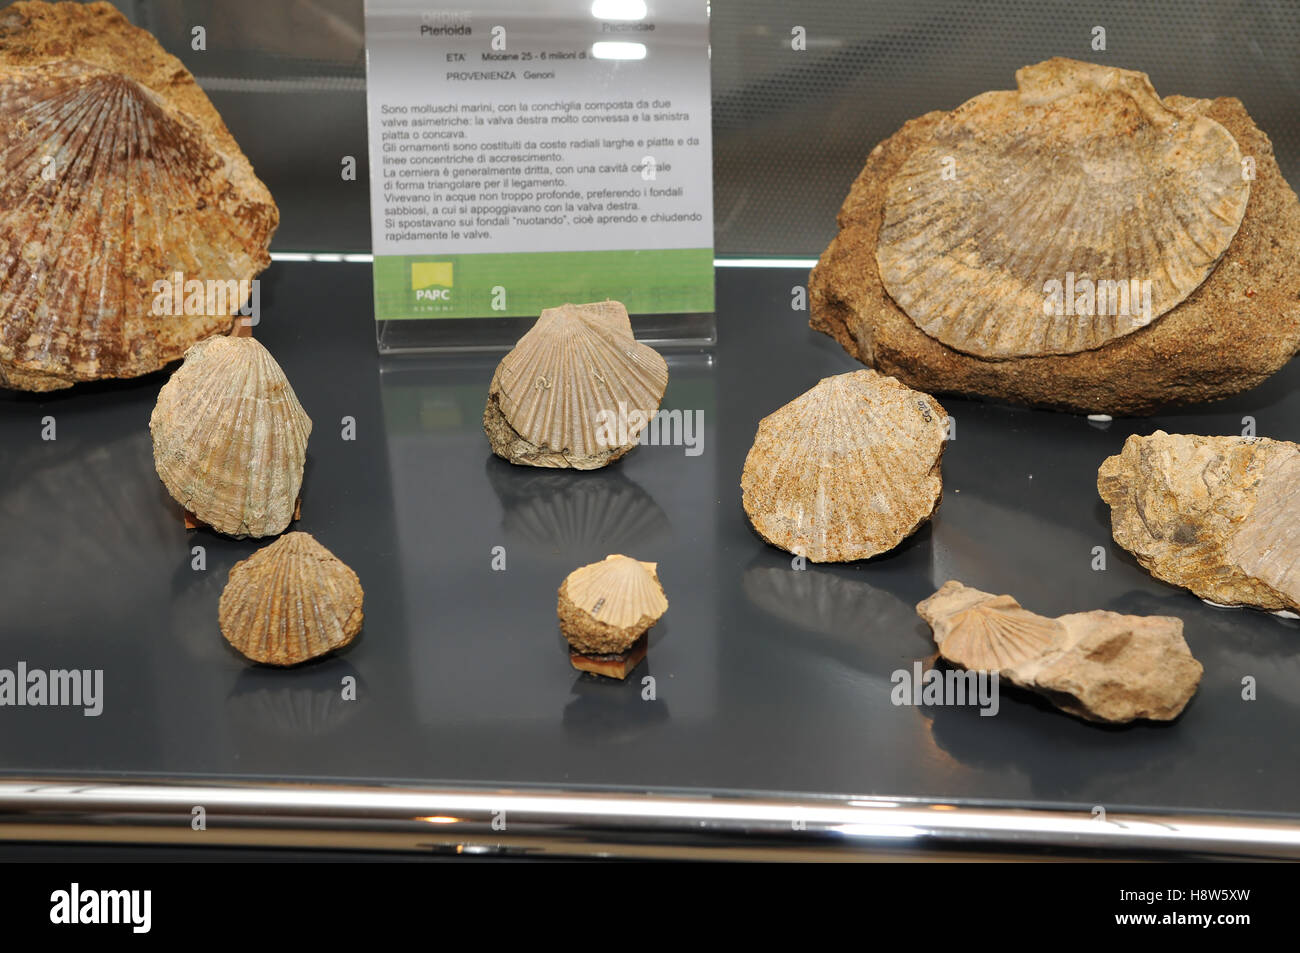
809;58;1300;415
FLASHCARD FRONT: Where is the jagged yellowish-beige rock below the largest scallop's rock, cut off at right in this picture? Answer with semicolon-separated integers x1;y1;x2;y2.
1097;430;1300;610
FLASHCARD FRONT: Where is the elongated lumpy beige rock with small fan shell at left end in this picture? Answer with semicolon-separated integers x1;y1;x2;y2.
917;581;1203;723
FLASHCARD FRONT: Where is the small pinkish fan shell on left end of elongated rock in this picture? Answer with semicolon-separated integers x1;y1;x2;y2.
917;581;1065;672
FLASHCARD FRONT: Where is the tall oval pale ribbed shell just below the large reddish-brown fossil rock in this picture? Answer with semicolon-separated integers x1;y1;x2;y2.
150;337;312;537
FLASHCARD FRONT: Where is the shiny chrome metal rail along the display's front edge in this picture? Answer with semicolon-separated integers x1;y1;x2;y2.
0;779;1300;861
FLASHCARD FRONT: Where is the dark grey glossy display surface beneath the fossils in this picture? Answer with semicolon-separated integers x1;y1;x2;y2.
0;264;1300;814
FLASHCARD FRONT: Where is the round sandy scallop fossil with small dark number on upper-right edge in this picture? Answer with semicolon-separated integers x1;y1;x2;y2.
741;371;948;563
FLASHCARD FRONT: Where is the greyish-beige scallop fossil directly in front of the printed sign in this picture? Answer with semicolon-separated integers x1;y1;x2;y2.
484;302;668;469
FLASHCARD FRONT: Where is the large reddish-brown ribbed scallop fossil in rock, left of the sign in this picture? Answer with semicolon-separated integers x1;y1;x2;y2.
0;4;280;391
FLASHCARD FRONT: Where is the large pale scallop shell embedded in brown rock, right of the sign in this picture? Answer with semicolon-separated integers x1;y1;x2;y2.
876;59;1251;359
